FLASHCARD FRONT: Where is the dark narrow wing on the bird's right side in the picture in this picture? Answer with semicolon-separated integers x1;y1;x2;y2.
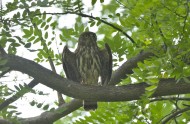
100;43;112;85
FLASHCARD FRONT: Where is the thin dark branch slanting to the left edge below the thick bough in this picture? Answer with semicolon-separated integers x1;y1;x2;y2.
0;80;38;111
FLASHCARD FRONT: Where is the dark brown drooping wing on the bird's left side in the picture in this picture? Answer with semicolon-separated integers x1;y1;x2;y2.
62;46;81;82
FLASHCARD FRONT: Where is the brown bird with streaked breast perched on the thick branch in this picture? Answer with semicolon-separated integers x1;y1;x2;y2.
62;32;112;110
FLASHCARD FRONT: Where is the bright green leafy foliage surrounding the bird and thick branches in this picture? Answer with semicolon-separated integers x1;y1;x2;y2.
0;0;190;124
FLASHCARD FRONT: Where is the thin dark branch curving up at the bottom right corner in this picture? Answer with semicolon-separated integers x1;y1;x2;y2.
162;107;190;124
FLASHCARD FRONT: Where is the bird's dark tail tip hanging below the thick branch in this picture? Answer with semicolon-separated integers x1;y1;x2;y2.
83;100;98;111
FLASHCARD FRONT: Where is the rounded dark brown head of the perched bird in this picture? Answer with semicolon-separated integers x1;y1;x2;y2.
78;32;97;47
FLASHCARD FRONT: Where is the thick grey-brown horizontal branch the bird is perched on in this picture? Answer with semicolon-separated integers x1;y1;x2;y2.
4;55;190;101
